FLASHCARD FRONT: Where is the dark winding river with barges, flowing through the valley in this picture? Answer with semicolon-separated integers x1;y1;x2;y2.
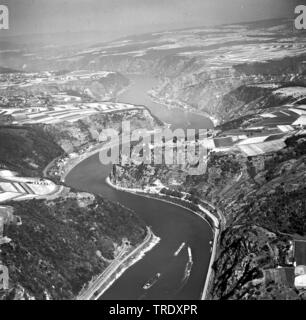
66;76;213;300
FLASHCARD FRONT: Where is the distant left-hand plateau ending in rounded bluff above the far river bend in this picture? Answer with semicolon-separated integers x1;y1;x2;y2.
0;71;129;104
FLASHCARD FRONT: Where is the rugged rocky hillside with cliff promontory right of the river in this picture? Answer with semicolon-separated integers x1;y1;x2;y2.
111;131;306;299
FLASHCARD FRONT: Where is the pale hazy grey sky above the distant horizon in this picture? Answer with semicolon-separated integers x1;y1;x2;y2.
0;0;298;40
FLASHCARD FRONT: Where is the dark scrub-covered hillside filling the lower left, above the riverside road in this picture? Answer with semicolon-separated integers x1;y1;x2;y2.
0;192;146;300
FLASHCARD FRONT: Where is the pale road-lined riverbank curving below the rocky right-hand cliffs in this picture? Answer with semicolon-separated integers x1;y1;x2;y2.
106;177;220;300
